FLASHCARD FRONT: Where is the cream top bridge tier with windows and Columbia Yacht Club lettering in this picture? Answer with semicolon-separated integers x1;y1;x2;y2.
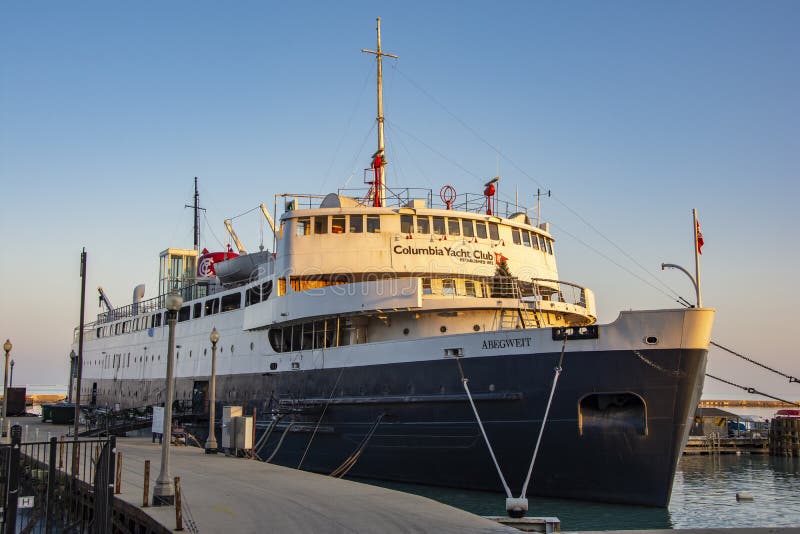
276;189;558;280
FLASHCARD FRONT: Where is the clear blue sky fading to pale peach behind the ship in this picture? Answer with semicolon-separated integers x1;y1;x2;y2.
0;0;800;399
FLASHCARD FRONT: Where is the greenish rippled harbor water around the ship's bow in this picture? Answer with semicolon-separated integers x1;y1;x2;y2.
362;455;800;530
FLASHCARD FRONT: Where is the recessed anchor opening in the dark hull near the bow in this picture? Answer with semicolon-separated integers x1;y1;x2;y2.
578;393;647;436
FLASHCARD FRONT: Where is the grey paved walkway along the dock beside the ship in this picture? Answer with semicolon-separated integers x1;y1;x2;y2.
10;418;519;534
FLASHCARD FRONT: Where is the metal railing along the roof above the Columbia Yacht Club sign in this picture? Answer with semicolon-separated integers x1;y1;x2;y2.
334;187;531;218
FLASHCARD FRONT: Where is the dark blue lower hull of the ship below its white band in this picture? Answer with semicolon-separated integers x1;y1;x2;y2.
101;349;706;506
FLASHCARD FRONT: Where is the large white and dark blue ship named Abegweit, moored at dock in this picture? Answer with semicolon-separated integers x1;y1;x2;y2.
73;20;714;507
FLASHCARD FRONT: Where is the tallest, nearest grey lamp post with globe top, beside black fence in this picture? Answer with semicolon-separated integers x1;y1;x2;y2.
153;291;183;506
